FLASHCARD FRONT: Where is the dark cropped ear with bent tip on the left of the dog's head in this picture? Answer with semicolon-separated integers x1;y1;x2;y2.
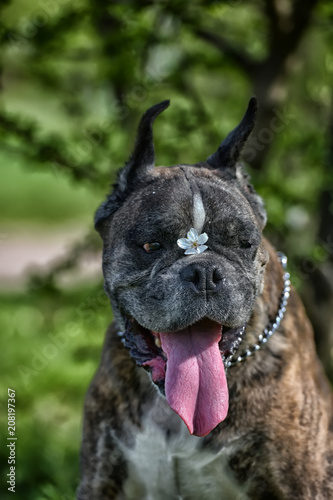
95;100;170;231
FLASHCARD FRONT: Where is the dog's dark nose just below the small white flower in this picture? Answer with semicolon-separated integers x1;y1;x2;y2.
180;263;224;292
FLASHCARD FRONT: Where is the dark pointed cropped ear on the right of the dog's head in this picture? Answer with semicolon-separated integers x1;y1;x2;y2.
207;97;258;177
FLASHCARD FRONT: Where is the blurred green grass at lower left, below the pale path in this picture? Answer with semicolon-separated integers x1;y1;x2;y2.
0;286;111;500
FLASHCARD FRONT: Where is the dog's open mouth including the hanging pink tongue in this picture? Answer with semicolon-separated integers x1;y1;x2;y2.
121;318;245;436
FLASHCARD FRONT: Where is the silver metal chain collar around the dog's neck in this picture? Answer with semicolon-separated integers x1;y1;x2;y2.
225;252;291;368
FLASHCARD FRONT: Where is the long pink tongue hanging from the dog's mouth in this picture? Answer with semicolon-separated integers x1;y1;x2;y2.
160;321;228;436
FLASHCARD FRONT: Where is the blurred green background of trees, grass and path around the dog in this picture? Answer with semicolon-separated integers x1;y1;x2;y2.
0;0;333;500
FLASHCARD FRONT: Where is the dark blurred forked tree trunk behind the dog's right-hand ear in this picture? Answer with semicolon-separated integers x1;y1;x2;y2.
196;0;318;170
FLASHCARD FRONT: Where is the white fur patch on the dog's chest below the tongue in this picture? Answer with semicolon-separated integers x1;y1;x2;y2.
115;400;246;500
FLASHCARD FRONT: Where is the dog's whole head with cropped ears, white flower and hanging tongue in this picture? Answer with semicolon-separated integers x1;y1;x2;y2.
95;98;267;436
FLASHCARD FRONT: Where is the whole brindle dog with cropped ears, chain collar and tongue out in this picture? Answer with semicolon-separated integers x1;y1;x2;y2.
77;97;333;500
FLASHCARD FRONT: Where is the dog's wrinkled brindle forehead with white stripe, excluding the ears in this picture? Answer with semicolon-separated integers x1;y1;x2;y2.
113;166;256;243
